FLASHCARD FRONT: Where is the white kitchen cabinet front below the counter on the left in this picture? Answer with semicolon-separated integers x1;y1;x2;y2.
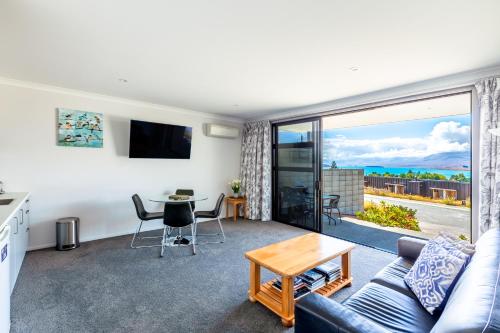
9;198;30;293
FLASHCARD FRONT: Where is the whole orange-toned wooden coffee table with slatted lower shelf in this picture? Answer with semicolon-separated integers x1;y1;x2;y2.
245;233;354;326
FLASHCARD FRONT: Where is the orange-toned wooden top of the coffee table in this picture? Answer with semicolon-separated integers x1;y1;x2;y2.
245;233;355;276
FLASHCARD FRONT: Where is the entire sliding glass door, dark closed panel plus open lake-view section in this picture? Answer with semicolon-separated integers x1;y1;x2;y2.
273;91;473;252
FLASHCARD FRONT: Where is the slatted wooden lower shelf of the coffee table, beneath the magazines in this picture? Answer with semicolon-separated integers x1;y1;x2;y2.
249;277;352;326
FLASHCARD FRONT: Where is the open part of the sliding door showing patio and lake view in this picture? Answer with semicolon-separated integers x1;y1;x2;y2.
321;92;472;252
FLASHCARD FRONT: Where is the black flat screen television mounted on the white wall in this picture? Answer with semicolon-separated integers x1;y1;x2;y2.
128;120;193;159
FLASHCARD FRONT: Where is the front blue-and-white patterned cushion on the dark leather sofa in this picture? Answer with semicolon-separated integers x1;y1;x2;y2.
404;239;470;314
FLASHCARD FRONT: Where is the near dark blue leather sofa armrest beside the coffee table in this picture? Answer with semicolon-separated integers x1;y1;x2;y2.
295;293;389;333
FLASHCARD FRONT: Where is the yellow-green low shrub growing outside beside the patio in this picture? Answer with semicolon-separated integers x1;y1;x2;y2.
356;201;420;231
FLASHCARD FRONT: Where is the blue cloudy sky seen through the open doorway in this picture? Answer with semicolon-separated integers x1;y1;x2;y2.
323;115;470;166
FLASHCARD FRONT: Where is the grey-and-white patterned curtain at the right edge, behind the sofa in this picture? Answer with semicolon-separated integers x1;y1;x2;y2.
476;77;500;233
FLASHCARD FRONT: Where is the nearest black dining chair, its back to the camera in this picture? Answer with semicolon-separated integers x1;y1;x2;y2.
160;202;196;257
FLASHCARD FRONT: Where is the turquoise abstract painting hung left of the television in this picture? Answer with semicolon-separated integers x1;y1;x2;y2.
57;108;103;148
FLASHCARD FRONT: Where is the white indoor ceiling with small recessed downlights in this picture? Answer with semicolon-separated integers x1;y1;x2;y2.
0;0;500;118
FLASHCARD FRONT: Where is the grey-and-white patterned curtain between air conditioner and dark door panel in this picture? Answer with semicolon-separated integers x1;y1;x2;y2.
240;121;271;221
